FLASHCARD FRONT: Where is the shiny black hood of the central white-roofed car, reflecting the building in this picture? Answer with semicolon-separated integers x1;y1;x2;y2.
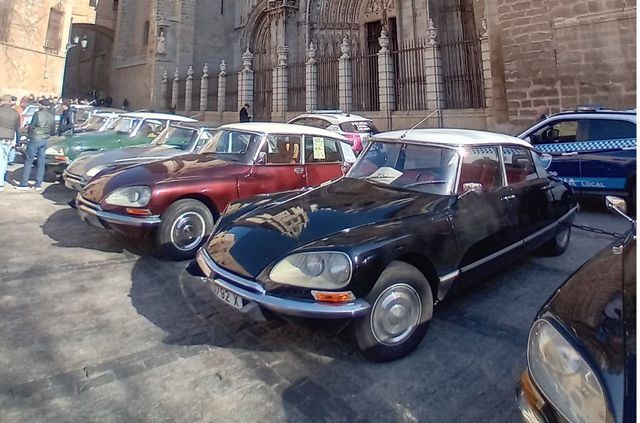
206;178;443;278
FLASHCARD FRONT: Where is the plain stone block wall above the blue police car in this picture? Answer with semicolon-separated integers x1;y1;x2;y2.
496;0;636;131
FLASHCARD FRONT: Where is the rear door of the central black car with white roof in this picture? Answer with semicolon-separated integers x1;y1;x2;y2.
502;146;561;247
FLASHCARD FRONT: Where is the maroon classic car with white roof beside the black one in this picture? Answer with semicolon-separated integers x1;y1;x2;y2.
76;123;355;259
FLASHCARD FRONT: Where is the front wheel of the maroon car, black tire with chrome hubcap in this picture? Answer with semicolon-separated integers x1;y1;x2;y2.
156;199;214;260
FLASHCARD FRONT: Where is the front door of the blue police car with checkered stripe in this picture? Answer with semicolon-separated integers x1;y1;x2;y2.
527;119;580;186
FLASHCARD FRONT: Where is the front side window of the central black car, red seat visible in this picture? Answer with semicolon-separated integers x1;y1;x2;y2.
458;146;504;193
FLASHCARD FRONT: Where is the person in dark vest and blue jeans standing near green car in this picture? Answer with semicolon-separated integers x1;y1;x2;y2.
16;99;56;191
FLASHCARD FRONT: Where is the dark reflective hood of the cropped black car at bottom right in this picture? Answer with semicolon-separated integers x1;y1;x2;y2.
541;241;636;421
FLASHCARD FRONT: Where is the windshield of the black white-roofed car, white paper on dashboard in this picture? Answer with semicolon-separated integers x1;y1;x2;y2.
347;141;460;195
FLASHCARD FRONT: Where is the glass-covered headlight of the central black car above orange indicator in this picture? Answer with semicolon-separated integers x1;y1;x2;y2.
269;252;351;289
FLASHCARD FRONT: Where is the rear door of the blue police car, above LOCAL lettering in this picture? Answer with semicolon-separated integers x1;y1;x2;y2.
576;119;636;191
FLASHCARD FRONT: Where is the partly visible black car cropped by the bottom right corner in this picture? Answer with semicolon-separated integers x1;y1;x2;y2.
516;197;636;423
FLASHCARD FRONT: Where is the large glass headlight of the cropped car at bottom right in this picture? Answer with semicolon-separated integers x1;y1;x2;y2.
527;320;607;422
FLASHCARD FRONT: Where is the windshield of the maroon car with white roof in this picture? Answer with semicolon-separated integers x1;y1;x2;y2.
200;129;262;164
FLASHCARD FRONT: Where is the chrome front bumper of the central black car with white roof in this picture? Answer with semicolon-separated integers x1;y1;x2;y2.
196;249;371;319
